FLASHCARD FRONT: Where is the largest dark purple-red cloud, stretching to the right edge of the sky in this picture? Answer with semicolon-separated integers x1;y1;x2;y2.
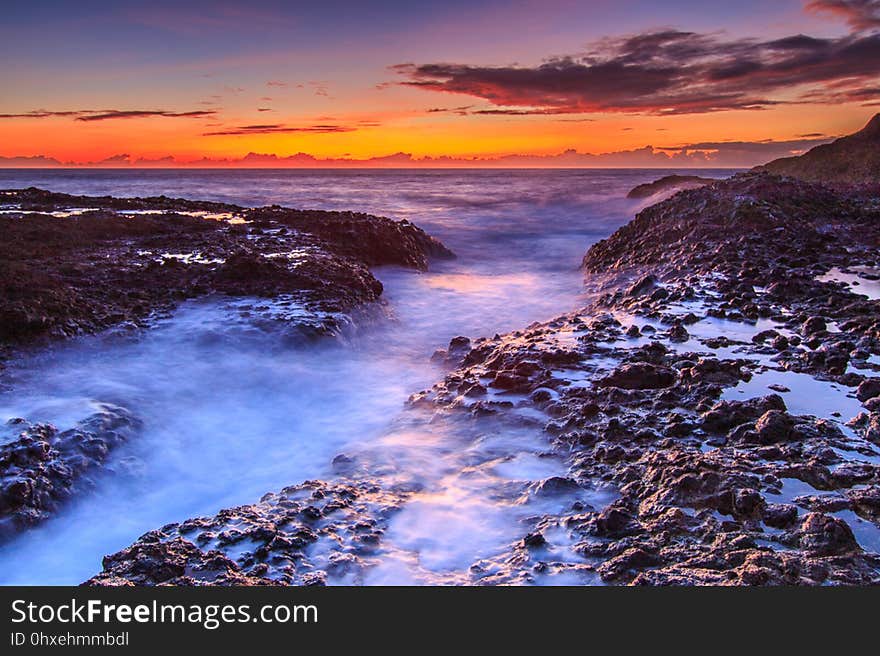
392;30;880;115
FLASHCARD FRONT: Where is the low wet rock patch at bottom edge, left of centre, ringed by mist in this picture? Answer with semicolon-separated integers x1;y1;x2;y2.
86;481;412;586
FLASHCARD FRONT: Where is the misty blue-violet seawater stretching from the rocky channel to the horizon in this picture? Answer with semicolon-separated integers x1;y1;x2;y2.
0;170;729;584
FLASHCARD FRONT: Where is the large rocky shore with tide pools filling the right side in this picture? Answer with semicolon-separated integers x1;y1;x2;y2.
419;174;880;585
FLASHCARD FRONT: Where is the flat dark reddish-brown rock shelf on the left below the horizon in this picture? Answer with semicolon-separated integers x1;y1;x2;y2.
0;188;452;346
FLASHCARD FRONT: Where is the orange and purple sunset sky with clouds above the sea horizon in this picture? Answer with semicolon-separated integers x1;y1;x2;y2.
0;0;880;166
